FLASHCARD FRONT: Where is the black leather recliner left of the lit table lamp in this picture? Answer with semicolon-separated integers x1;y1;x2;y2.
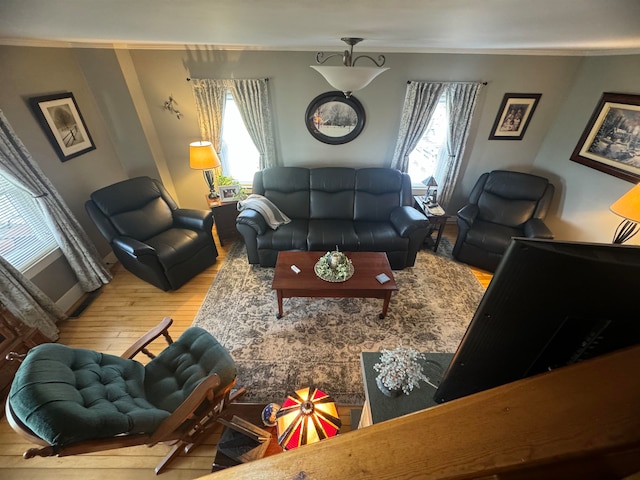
85;177;218;291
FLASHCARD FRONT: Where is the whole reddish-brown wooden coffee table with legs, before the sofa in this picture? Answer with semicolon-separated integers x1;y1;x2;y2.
271;251;398;318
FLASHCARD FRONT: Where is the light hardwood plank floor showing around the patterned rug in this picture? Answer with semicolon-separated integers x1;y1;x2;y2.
0;226;491;480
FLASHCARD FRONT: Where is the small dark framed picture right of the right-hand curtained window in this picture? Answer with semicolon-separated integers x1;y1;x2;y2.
489;93;542;140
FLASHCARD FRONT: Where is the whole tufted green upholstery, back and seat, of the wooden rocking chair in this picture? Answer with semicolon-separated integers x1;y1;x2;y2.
9;327;235;445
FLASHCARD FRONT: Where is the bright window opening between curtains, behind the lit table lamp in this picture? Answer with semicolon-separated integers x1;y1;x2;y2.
221;93;260;185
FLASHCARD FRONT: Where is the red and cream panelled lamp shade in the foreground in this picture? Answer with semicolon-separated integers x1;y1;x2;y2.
276;387;342;450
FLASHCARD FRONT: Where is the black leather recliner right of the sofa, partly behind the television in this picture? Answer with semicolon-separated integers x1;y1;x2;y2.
453;170;554;272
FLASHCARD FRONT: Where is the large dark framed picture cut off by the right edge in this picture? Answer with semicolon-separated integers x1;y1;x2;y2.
571;93;640;183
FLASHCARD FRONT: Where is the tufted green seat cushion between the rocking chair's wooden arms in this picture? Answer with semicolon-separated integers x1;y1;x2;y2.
144;327;236;412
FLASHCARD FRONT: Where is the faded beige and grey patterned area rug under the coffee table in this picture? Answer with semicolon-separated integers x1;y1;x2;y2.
193;239;484;405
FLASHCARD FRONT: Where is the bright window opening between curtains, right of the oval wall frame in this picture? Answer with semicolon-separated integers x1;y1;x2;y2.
408;93;447;186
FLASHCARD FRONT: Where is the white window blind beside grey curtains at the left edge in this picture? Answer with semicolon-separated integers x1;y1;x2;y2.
0;174;58;272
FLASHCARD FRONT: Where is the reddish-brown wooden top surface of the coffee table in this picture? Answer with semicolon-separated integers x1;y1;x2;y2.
271;251;398;291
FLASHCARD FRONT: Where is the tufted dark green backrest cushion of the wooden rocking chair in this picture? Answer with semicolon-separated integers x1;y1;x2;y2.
9;343;170;445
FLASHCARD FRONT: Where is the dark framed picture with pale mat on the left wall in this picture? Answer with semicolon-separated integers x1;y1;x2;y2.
29;93;96;162
